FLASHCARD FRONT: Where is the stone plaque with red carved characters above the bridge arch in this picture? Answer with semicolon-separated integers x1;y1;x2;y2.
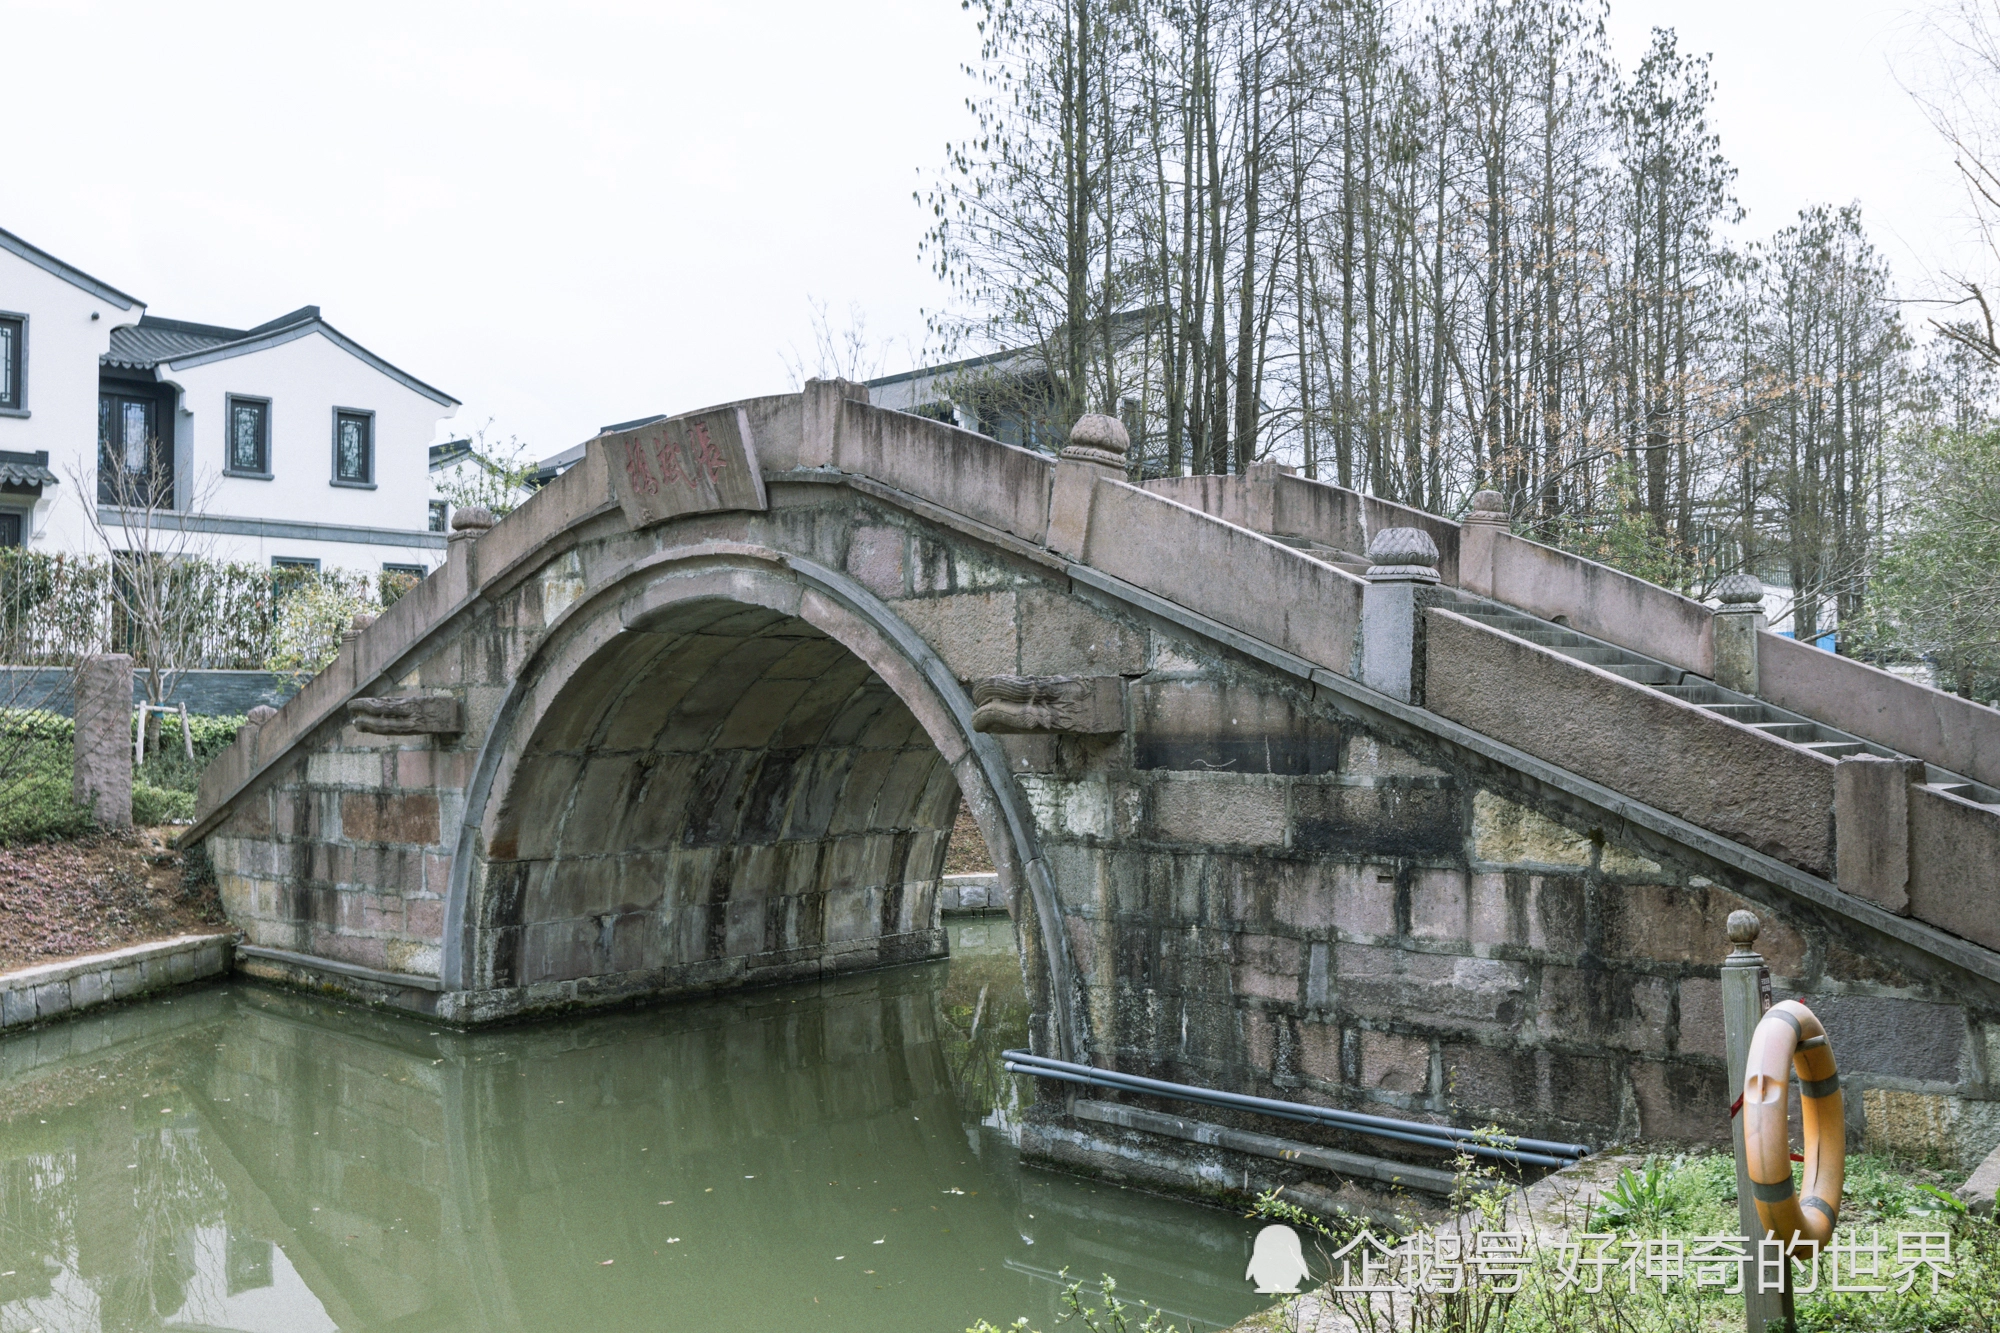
598;408;768;528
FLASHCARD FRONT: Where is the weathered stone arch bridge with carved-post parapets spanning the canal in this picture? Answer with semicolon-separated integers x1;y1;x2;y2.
186;382;2000;1157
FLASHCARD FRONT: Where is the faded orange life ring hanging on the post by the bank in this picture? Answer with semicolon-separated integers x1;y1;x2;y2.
1744;1001;1848;1245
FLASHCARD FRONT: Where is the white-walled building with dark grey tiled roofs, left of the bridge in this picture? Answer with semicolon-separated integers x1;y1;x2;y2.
0;230;458;572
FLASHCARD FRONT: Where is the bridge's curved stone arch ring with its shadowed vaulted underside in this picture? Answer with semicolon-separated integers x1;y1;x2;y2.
442;542;1082;1055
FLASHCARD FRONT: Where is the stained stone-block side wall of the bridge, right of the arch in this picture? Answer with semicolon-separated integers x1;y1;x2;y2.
1020;600;2000;1161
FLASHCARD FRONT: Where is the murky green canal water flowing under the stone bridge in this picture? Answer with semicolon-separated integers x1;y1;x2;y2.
0;919;1260;1333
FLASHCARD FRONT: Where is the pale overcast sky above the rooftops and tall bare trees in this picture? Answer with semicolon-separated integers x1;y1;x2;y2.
0;0;1966;456
